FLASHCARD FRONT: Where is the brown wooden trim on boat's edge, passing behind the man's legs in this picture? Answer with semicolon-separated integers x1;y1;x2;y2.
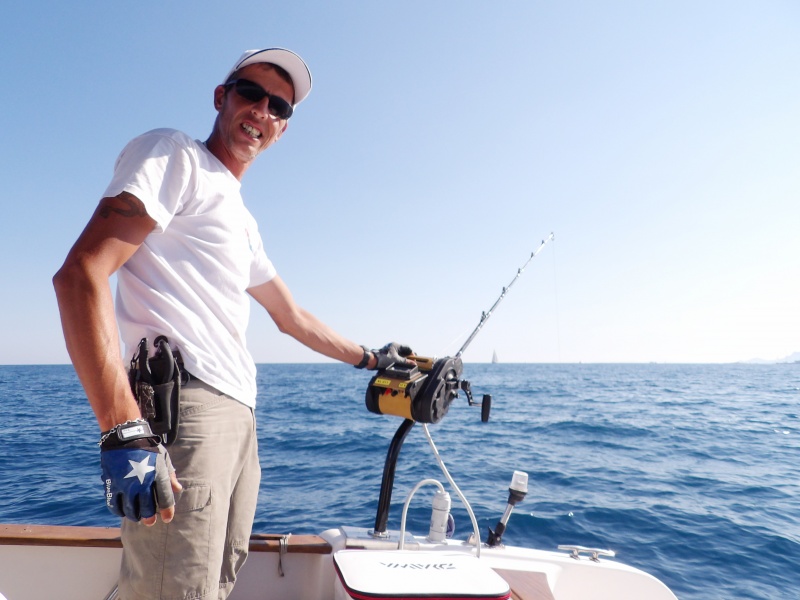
0;524;331;554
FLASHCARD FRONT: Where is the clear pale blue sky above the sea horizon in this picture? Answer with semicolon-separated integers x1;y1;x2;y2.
0;0;800;363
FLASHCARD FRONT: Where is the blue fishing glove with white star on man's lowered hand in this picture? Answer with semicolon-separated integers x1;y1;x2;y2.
99;420;175;521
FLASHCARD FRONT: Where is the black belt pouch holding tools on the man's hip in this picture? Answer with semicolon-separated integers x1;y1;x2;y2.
128;335;181;446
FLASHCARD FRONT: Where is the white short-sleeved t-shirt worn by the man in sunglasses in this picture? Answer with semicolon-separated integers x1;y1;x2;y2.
104;129;275;406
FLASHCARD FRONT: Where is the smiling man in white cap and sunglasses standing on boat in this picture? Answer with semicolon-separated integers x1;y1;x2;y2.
53;48;411;600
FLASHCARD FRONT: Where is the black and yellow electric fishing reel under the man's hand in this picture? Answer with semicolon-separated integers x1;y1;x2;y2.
366;356;492;423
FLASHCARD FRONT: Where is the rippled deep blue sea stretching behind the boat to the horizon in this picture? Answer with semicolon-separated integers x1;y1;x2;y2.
0;364;800;600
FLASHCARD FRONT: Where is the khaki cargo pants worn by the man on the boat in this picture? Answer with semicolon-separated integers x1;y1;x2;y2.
119;378;261;600
